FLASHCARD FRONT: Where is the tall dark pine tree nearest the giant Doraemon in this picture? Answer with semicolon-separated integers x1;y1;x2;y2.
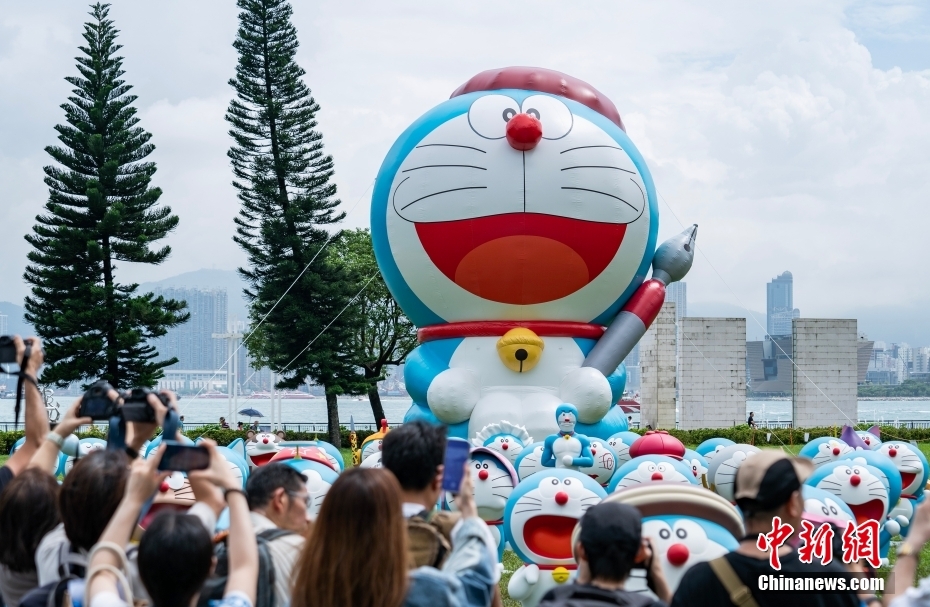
226;0;367;446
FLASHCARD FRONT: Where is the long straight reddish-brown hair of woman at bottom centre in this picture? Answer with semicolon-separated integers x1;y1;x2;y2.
291;468;407;607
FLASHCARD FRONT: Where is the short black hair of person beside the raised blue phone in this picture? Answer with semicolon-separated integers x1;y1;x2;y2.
380;422;446;499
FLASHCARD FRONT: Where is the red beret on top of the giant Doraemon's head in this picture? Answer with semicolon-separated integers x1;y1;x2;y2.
449;66;626;132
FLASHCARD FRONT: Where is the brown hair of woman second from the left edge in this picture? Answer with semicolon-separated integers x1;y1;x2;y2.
58;450;129;550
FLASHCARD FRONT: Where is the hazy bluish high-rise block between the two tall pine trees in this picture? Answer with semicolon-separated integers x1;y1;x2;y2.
152;287;227;370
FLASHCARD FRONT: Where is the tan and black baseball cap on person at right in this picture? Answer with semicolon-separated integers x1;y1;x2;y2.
734;449;814;514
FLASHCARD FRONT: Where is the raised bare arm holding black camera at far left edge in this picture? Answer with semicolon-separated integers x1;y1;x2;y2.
0;335;48;494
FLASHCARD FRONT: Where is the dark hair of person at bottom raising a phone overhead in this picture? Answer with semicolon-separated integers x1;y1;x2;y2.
139;512;213;607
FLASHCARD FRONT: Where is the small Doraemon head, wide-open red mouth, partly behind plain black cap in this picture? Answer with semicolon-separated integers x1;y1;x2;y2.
504;468;607;566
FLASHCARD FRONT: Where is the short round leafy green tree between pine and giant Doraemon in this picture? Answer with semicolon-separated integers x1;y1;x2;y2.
334;229;417;422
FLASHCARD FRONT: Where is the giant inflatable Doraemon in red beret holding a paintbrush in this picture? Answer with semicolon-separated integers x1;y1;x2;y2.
371;67;696;446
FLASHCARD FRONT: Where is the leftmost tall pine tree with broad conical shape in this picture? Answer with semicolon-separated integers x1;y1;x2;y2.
24;3;189;388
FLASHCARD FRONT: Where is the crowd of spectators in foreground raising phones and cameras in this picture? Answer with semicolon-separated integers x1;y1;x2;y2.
0;337;930;607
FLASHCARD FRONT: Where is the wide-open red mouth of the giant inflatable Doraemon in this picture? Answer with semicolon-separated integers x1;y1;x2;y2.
416;213;626;305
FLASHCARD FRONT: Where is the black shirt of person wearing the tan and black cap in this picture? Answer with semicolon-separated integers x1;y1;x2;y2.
671;551;859;607
